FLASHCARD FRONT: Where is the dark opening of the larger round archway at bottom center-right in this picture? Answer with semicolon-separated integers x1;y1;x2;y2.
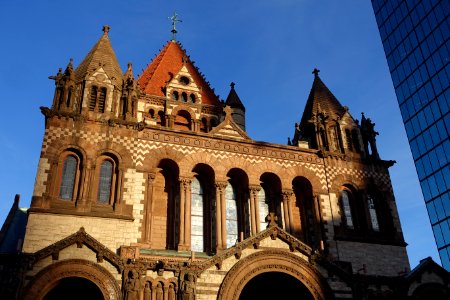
239;272;314;300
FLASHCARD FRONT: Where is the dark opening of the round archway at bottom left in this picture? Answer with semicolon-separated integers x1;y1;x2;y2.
43;277;104;300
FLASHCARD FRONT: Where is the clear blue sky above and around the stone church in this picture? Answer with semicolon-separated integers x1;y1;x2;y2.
0;0;440;267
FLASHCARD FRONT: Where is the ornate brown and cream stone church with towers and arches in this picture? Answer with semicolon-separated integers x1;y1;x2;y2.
0;26;450;300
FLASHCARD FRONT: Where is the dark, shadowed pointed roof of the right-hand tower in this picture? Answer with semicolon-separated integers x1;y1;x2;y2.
300;69;346;126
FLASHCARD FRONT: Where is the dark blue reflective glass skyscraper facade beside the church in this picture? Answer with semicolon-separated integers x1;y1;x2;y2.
372;0;450;271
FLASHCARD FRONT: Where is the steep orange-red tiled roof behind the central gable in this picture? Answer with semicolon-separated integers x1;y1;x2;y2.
138;41;221;105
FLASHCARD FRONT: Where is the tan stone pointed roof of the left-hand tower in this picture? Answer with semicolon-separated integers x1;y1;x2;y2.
75;25;123;83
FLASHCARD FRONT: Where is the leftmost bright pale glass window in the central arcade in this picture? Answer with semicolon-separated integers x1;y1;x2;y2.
191;177;205;252
